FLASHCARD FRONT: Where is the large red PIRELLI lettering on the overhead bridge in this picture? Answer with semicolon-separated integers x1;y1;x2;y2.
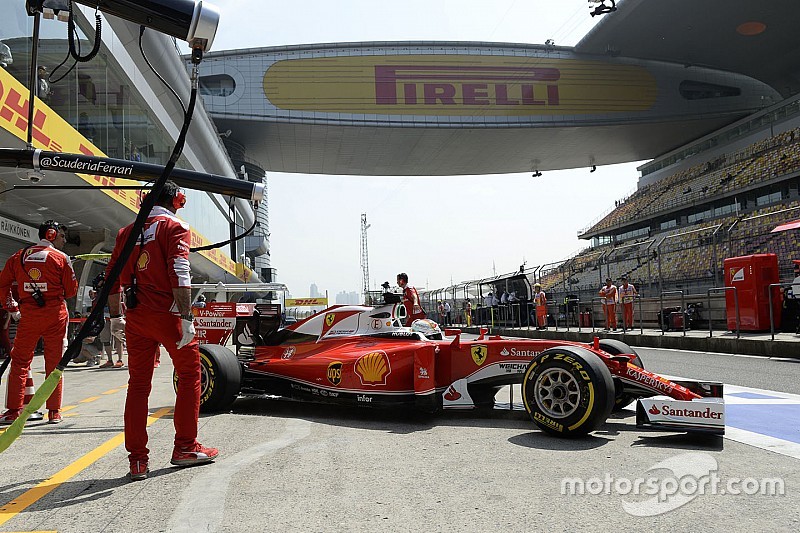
375;65;561;107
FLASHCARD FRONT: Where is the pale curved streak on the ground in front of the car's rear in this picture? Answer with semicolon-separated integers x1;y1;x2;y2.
167;420;311;533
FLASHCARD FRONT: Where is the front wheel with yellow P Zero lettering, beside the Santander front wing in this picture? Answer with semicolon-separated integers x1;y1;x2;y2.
522;346;614;437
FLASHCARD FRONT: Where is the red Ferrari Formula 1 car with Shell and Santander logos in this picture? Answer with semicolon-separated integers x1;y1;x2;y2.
188;295;725;436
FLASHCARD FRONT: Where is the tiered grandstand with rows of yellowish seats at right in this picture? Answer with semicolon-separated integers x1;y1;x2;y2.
423;93;800;321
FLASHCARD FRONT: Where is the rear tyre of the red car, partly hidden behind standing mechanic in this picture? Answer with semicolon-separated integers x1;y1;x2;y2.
172;344;242;413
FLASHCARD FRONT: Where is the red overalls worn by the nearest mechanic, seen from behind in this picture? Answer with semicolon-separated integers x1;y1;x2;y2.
106;206;200;461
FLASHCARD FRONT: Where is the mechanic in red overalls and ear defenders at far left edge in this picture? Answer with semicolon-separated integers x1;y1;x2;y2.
0;220;78;425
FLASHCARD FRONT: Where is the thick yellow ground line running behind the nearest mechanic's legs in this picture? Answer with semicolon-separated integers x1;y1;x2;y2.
0;407;172;526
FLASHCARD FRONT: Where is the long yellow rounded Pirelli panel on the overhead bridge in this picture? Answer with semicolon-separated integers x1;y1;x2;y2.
264;55;657;117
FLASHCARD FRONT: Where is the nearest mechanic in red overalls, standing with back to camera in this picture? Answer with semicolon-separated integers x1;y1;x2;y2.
106;181;219;481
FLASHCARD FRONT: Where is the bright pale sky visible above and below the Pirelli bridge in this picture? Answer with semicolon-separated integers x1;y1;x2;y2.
206;0;641;302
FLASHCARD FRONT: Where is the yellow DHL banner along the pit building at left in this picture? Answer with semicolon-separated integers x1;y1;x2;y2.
0;68;250;281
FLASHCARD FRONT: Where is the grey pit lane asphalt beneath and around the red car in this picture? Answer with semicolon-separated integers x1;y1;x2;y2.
0;342;800;532
